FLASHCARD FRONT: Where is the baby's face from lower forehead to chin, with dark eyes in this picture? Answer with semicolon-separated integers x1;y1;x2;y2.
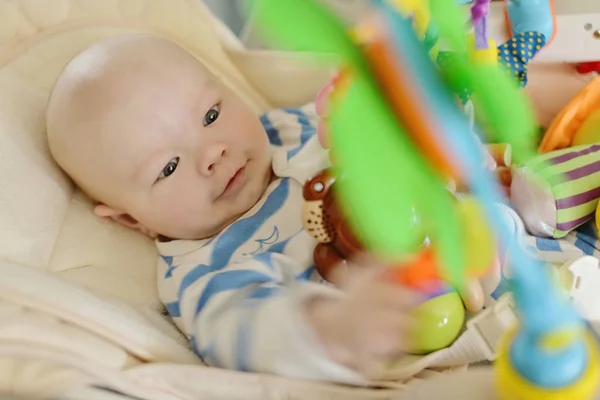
109;74;271;239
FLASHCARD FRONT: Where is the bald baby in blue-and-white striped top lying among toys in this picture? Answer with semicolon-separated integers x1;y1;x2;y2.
47;35;488;384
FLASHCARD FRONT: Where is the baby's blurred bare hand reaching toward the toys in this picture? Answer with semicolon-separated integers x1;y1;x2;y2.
306;267;421;375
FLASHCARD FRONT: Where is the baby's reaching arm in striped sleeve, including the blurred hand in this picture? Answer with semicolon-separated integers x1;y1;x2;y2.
169;253;414;384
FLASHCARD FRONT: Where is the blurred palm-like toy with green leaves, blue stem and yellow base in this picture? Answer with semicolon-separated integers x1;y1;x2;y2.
258;0;599;399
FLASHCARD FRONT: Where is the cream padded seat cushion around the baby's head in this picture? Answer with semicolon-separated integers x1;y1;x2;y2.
0;0;327;309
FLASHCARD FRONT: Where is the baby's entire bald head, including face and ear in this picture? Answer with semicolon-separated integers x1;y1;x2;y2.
49;36;271;239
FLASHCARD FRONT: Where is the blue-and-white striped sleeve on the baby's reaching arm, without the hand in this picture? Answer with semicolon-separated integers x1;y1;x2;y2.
171;253;361;383
